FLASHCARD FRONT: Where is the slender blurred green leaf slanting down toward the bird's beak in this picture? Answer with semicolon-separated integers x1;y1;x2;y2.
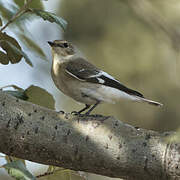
19;34;47;60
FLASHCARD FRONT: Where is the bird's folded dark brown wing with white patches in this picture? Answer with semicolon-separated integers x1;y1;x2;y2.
66;58;143;97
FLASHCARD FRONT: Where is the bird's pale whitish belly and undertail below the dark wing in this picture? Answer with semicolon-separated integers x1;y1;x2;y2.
52;74;137;105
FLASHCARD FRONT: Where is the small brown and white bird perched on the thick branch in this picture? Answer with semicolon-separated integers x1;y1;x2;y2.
48;40;162;115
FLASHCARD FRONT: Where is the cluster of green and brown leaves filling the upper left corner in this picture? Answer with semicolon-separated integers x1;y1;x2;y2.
0;0;67;66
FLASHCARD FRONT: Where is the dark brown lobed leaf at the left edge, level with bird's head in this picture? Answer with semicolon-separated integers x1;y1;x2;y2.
0;32;22;64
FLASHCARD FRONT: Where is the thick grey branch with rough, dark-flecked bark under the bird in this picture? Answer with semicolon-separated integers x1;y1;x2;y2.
0;92;180;180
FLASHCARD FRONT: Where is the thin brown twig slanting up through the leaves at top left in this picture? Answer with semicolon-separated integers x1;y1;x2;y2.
0;0;32;32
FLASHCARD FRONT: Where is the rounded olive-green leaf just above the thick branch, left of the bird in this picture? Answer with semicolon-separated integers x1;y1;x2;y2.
25;85;55;109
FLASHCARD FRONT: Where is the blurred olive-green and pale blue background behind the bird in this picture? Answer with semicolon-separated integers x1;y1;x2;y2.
0;0;180;179
